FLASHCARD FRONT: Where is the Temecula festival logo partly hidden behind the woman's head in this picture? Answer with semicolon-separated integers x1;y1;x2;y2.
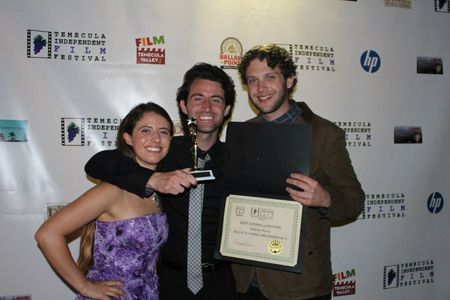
61;117;122;148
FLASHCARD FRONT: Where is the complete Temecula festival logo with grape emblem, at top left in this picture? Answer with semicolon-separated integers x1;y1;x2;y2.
27;29;107;62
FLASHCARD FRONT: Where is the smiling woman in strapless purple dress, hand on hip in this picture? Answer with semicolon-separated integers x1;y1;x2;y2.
35;102;195;300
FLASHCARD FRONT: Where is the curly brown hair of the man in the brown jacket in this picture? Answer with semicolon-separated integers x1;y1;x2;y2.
238;44;297;91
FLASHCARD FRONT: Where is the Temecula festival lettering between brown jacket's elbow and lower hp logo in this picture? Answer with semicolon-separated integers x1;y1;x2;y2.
359;193;406;219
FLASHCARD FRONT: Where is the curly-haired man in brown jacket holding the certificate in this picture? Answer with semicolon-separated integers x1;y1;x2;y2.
233;45;365;300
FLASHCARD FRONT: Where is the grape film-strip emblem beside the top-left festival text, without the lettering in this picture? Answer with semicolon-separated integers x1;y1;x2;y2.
27;29;52;59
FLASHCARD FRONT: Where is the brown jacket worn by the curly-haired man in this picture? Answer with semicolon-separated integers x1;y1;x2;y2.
233;102;365;300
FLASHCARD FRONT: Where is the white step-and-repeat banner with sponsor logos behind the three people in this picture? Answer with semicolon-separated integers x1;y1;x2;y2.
0;0;450;300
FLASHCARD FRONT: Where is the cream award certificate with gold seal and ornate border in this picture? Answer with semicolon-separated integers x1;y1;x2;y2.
220;195;302;267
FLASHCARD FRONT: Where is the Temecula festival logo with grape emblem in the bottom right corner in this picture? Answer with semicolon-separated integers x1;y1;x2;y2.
383;259;434;289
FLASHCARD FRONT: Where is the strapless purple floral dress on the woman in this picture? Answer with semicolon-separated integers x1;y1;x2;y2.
75;213;168;300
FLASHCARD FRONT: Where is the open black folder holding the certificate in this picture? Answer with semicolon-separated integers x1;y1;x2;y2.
214;122;312;273
